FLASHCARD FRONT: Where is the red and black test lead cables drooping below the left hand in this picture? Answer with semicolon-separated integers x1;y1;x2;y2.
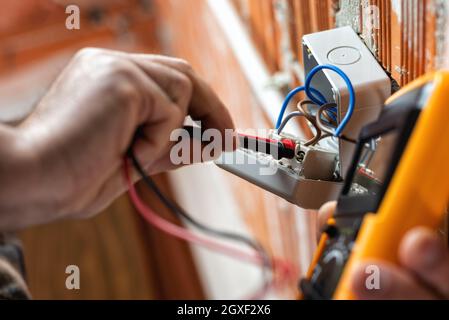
124;152;292;299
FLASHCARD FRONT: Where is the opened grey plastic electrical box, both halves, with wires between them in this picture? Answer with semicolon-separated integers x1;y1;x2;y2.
216;27;391;209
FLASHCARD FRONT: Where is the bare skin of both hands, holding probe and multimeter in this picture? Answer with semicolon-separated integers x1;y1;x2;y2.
0;49;449;299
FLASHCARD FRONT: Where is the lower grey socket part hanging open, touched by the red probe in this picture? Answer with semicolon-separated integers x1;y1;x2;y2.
215;134;343;209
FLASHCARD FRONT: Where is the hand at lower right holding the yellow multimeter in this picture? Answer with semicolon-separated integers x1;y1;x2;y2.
319;202;449;300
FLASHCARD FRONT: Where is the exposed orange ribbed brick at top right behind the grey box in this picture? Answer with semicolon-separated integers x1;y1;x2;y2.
232;0;449;85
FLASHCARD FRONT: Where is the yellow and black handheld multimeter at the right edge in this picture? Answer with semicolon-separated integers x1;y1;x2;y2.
300;71;449;299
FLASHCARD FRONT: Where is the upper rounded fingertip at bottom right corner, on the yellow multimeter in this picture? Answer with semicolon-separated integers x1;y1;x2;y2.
399;228;449;299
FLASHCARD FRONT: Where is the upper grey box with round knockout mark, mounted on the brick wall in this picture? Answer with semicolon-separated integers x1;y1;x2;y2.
302;26;392;177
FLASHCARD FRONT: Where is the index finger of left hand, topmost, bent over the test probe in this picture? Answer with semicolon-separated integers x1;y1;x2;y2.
144;55;235;138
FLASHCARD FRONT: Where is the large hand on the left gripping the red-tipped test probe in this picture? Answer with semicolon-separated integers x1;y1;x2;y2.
0;49;234;229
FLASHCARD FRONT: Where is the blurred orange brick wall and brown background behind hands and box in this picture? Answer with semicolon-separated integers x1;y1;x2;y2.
0;0;448;299
